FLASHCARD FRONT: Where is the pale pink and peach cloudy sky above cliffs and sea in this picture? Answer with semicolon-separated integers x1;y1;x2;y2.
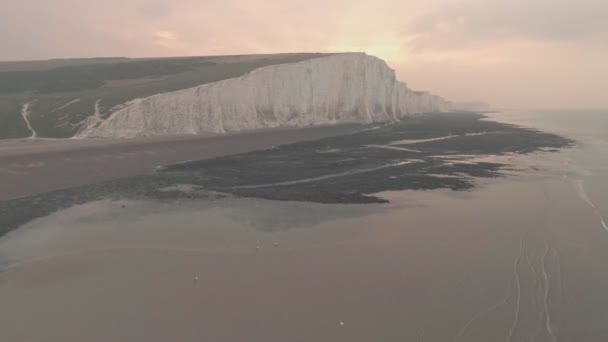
0;0;608;109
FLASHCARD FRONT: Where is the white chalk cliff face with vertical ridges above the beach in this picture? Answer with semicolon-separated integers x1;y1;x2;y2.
79;53;448;137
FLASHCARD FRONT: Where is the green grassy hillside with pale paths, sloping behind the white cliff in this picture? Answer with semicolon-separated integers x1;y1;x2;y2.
0;54;332;139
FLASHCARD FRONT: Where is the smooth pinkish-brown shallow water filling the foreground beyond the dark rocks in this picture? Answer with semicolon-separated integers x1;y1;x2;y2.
0;113;608;341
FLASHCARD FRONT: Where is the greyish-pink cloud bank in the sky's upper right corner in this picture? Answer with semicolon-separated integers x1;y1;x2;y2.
402;0;608;50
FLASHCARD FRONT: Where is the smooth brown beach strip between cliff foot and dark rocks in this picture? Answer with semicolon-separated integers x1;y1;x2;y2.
0;124;362;201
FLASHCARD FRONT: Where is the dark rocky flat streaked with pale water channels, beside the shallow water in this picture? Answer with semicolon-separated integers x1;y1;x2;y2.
0;113;574;235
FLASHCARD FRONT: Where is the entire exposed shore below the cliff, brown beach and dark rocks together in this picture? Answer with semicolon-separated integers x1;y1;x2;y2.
0;113;572;240
